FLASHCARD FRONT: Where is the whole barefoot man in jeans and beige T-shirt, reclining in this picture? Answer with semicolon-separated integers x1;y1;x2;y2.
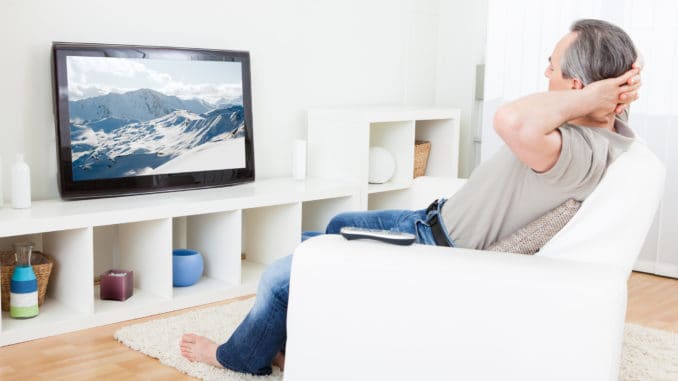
180;20;640;375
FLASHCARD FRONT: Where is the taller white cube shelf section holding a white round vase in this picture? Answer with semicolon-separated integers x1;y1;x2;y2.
308;107;460;209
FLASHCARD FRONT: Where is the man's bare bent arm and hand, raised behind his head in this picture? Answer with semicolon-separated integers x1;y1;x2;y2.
494;69;638;172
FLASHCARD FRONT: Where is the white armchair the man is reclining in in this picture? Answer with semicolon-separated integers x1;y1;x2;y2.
285;142;665;381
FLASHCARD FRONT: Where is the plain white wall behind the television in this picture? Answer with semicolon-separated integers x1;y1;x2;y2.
0;0;439;199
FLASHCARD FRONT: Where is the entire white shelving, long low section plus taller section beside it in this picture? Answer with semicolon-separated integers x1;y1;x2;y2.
0;107;459;346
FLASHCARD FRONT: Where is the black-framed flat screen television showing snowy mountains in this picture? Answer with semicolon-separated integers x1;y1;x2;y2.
52;43;254;199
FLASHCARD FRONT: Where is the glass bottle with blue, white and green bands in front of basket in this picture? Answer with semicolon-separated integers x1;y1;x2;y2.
9;242;38;319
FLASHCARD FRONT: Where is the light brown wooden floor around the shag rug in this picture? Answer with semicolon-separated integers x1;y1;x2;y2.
0;273;678;381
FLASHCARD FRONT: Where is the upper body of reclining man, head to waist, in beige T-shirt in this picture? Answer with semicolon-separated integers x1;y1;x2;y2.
441;20;640;249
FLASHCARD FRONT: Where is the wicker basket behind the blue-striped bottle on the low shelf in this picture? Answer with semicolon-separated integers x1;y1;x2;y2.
0;251;54;311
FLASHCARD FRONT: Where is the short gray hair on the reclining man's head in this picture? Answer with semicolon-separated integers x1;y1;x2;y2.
560;19;638;85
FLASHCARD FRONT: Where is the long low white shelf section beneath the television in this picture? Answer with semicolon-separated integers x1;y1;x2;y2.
0;179;360;346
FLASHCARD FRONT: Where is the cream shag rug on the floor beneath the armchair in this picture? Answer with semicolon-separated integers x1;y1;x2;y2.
115;298;678;381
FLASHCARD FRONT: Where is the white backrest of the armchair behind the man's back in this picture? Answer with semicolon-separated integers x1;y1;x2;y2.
539;140;666;272
